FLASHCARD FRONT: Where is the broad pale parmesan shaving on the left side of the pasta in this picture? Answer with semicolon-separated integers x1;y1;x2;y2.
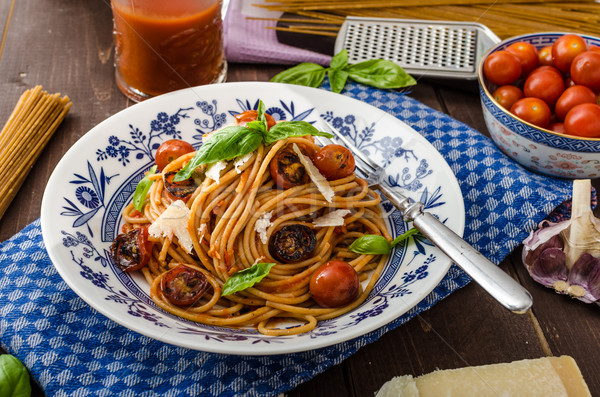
148;200;194;253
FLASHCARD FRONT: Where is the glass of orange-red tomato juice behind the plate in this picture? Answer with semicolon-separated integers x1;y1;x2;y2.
111;0;227;102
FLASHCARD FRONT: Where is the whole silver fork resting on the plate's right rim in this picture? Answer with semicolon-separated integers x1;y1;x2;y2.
315;122;533;313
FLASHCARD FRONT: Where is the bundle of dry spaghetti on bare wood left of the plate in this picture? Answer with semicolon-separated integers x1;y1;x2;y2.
0;85;71;218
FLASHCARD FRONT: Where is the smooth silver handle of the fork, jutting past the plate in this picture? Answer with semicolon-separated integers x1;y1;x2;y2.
381;188;533;313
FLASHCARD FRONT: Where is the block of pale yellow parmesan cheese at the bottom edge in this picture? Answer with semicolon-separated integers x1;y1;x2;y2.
376;356;591;397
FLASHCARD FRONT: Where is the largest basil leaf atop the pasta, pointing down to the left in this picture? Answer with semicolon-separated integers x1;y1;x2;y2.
173;127;263;182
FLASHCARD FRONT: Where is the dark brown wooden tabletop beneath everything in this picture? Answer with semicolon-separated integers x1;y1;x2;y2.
0;0;600;396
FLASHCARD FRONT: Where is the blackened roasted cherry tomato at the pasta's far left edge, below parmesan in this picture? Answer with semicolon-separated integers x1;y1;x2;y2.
110;226;153;272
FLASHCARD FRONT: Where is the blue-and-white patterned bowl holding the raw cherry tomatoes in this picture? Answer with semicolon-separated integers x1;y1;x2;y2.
477;33;600;179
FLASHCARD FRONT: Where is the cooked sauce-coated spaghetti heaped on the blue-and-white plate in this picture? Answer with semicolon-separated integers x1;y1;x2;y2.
114;114;391;335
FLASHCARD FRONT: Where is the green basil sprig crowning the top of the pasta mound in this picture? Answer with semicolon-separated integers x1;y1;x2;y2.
173;101;333;182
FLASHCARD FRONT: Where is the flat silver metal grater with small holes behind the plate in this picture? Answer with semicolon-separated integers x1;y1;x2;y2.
335;17;500;79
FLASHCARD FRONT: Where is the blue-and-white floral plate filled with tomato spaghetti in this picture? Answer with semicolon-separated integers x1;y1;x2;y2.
41;82;465;355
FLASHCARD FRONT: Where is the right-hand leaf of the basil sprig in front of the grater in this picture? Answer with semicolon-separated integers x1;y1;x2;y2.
345;59;417;88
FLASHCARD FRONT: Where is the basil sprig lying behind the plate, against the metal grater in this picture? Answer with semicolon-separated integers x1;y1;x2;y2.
271;49;417;92
